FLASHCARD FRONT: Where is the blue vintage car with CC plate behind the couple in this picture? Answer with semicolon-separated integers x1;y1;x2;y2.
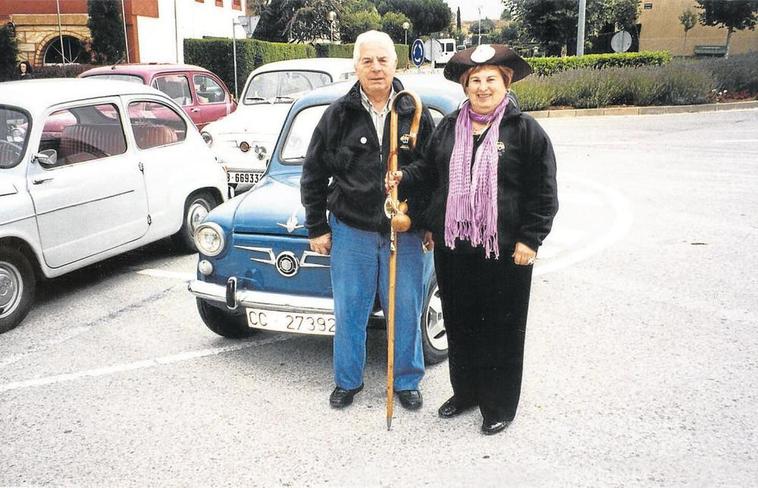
189;74;464;364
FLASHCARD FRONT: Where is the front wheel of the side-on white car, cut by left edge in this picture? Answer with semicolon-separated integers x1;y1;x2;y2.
0;246;37;333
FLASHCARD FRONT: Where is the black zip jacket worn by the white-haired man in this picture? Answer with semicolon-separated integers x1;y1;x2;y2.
300;78;433;238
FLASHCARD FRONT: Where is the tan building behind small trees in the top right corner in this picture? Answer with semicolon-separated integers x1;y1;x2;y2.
639;0;758;56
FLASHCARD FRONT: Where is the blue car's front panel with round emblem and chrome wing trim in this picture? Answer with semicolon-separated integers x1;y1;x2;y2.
214;233;332;297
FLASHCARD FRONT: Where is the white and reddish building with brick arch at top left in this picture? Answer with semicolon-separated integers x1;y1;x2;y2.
0;0;245;66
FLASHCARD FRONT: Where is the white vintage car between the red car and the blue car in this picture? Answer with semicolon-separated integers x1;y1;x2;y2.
202;58;355;193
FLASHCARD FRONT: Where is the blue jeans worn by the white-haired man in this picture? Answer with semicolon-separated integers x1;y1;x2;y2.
329;215;424;390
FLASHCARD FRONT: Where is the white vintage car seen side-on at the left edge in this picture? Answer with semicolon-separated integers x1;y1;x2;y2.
0;79;228;333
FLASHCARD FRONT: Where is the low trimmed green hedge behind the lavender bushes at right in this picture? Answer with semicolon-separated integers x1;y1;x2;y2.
527;51;671;76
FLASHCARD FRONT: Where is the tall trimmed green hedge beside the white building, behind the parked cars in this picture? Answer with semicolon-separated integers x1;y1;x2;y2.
184;39;316;96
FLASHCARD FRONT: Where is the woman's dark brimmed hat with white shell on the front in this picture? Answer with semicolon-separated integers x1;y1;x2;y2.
444;44;532;83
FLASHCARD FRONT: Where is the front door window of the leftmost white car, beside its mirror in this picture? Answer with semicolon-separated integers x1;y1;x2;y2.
39;103;126;166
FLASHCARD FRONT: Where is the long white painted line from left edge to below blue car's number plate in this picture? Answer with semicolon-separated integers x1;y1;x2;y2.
0;334;293;393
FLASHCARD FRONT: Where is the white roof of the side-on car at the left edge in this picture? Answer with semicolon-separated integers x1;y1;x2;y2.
0;78;167;113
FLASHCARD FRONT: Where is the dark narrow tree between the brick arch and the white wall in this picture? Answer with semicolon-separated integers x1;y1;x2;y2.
87;0;126;64
